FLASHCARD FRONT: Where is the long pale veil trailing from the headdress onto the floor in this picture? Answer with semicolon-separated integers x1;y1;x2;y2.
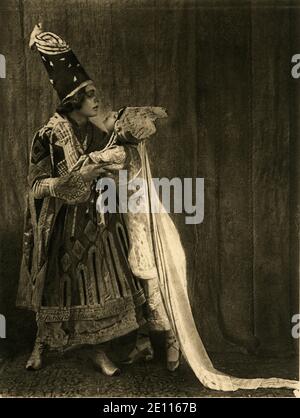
139;142;299;391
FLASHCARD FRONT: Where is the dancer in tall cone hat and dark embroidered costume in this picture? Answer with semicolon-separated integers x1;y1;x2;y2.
17;23;145;375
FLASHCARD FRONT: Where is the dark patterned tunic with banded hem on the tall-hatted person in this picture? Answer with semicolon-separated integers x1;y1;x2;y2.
18;114;145;349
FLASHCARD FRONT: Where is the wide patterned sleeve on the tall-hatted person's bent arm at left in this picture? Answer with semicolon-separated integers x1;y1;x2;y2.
28;130;91;204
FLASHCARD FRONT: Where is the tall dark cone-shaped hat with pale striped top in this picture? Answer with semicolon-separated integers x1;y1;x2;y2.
29;24;93;101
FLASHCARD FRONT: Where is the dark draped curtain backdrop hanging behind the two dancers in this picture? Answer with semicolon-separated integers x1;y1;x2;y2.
0;0;300;355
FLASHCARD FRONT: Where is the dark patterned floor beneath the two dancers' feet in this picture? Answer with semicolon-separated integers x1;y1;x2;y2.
0;354;297;397
